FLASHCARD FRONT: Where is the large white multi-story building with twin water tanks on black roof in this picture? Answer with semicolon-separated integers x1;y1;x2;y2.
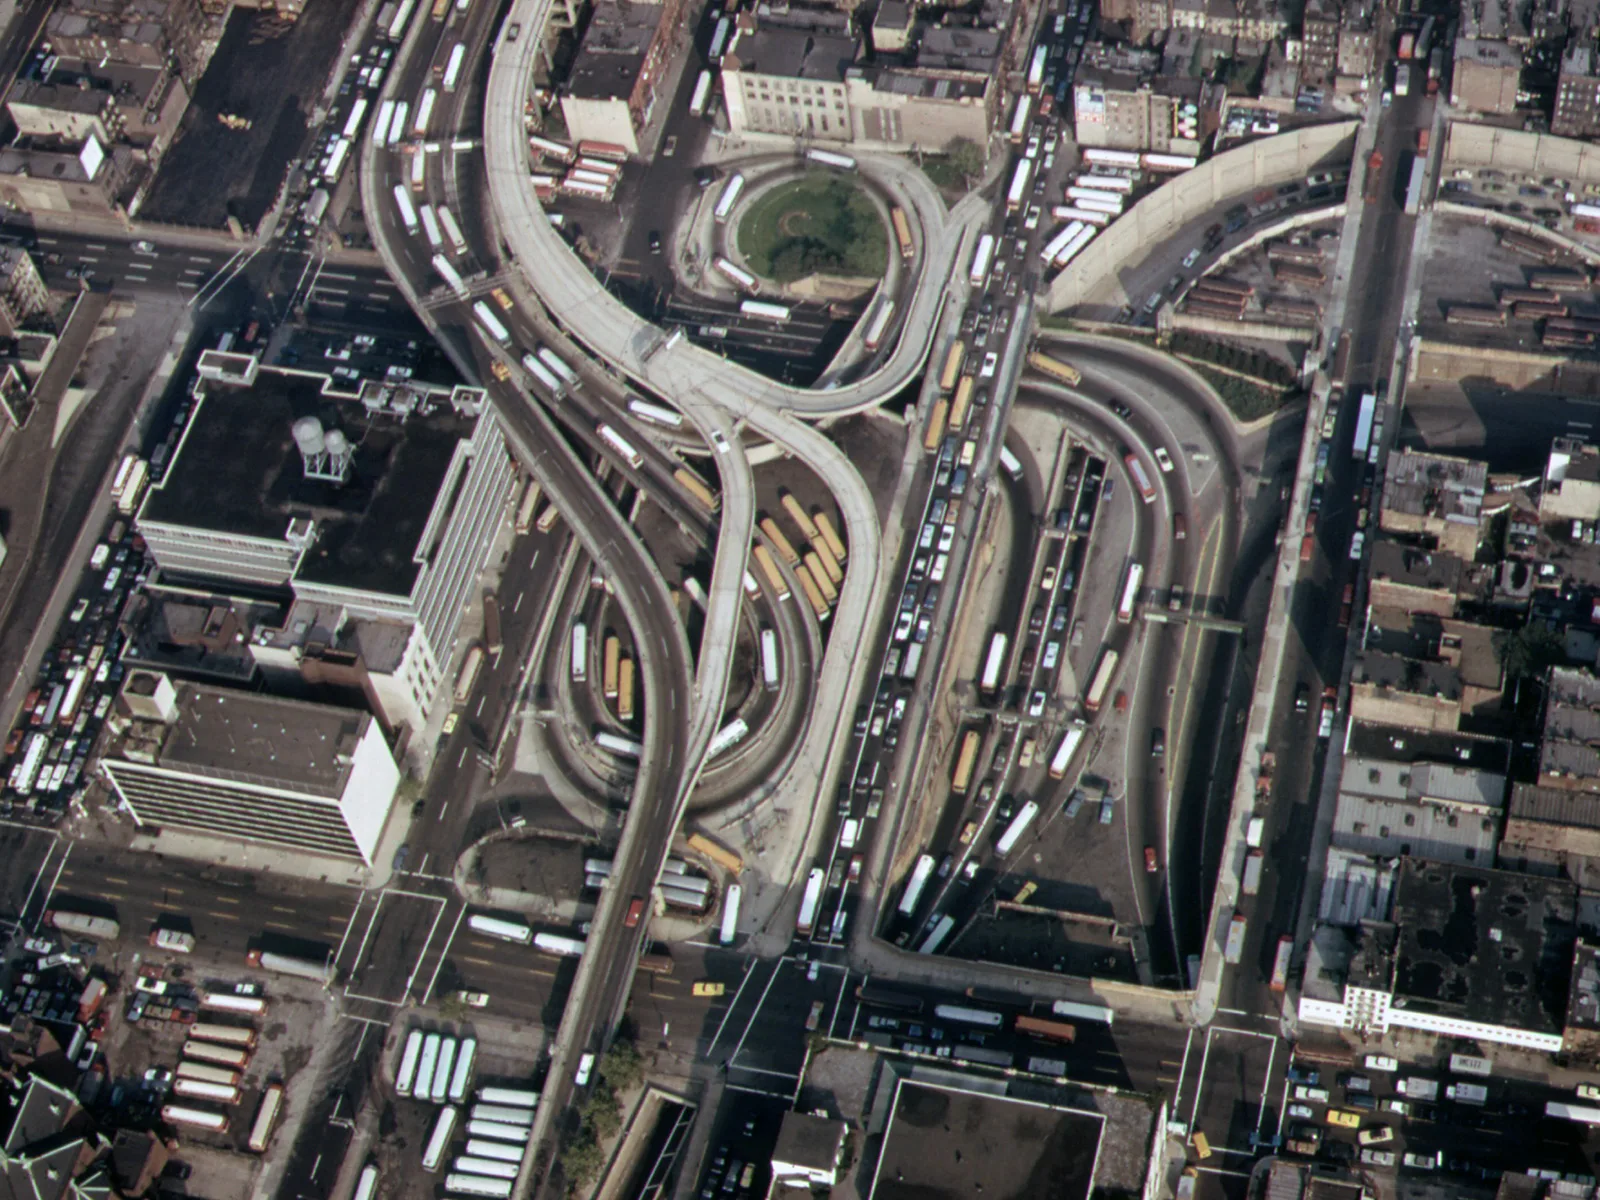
138;352;515;739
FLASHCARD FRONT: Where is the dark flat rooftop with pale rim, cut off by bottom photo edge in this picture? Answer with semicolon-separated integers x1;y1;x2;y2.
869;1080;1106;1200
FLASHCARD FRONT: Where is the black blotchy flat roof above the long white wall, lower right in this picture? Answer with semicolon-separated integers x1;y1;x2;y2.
1394;858;1578;1034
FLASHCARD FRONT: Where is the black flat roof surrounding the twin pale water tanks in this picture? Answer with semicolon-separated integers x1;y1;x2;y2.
139;366;477;595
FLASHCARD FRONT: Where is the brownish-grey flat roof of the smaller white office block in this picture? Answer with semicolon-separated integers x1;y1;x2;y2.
140;677;371;800
